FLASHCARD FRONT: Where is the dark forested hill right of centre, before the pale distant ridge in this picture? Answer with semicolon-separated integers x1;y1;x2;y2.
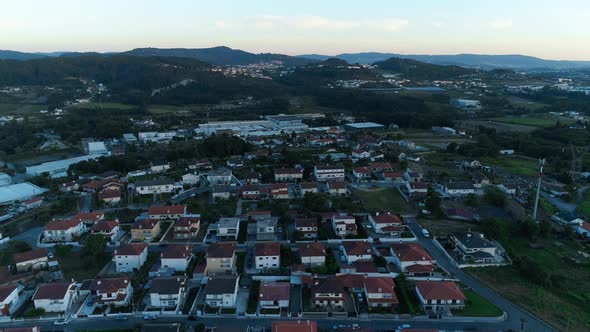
374;58;479;80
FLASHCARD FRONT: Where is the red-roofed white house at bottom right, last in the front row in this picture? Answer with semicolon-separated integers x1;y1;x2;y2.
416;281;467;315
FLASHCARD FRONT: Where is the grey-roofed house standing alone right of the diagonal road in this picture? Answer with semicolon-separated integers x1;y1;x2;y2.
449;232;496;263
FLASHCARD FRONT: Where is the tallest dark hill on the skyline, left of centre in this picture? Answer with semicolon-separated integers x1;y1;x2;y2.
121;46;314;66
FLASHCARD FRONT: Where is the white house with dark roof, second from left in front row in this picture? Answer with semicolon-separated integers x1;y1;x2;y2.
33;282;78;312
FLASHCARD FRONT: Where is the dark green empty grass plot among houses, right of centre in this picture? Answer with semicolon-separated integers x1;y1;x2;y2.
352;188;408;213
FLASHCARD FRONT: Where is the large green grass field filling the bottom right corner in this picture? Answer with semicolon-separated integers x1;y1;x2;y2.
466;238;590;331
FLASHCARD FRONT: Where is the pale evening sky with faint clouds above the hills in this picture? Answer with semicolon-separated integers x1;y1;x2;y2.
0;0;590;60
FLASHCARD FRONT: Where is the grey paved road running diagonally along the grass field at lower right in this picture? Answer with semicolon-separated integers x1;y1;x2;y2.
406;218;555;331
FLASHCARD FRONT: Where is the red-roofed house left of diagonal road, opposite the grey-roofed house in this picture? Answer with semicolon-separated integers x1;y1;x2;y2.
390;243;436;277
